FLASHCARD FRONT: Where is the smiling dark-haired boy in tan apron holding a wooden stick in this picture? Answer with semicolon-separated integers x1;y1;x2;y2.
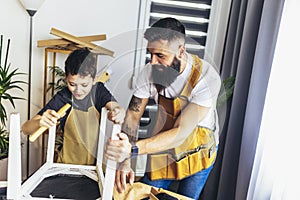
22;48;125;165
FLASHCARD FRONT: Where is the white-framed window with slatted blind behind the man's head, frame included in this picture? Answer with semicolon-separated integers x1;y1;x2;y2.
132;0;231;72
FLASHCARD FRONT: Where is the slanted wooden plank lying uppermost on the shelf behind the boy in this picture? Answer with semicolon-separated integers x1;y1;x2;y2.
50;28;114;57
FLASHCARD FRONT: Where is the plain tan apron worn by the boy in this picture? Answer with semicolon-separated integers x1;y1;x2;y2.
57;96;100;165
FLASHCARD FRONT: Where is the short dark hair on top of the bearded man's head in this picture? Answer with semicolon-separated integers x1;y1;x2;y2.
144;17;185;42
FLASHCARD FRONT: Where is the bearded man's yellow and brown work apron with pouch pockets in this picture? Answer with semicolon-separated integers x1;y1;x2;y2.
148;55;216;180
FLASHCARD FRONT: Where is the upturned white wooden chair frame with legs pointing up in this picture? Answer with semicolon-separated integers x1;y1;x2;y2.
7;108;120;200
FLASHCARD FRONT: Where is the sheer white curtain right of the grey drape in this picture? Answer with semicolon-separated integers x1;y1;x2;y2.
247;0;300;200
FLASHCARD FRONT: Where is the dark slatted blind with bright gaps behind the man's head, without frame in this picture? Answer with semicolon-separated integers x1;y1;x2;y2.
145;0;212;57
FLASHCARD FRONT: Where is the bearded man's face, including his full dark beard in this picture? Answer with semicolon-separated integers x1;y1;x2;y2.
147;40;181;88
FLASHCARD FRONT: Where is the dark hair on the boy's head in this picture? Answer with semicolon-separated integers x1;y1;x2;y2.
65;48;97;78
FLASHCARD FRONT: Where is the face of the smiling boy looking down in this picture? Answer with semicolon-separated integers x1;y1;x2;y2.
66;74;96;100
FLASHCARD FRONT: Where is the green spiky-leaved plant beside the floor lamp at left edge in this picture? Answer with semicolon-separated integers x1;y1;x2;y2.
0;35;26;180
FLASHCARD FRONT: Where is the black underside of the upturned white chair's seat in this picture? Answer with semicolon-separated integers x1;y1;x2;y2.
30;174;100;200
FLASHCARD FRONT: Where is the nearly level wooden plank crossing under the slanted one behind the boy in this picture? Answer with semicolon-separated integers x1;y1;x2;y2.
37;34;106;47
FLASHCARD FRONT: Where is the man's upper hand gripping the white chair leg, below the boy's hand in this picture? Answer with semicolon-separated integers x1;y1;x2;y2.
105;133;131;162
